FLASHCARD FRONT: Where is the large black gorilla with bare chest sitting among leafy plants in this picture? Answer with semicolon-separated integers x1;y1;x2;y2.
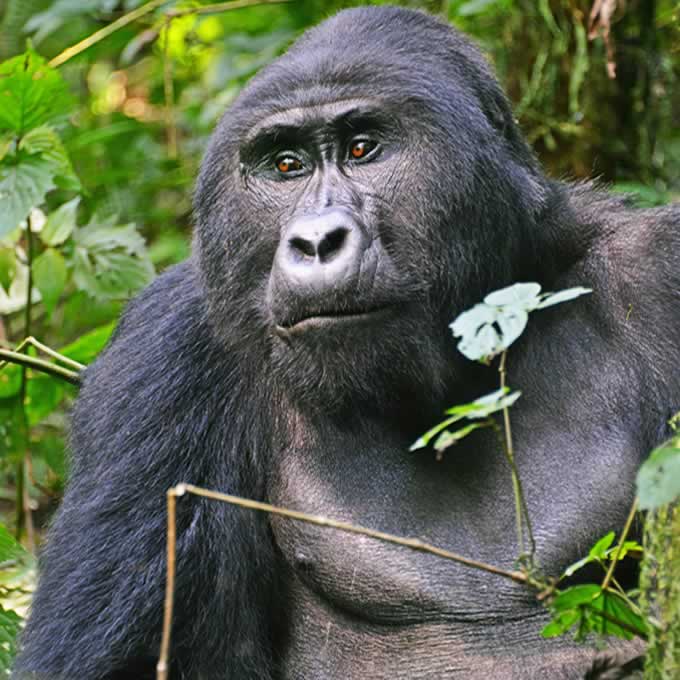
15;7;680;680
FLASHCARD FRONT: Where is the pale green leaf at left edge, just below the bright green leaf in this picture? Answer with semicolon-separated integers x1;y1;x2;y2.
0;155;55;238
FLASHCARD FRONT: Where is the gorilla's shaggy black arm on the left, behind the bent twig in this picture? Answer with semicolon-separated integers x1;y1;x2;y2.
13;262;273;680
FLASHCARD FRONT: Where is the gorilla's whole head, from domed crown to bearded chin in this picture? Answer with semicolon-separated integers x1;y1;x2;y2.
196;8;543;405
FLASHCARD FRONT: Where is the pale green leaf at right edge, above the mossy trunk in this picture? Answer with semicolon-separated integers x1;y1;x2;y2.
637;437;680;510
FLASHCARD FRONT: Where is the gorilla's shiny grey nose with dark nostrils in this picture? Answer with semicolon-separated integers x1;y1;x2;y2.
278;210;367;290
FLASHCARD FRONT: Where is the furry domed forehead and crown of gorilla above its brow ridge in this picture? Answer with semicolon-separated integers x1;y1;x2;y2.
223;7;504;136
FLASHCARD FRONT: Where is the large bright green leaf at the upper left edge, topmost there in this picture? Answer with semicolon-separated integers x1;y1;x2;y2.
0;50;71;137
